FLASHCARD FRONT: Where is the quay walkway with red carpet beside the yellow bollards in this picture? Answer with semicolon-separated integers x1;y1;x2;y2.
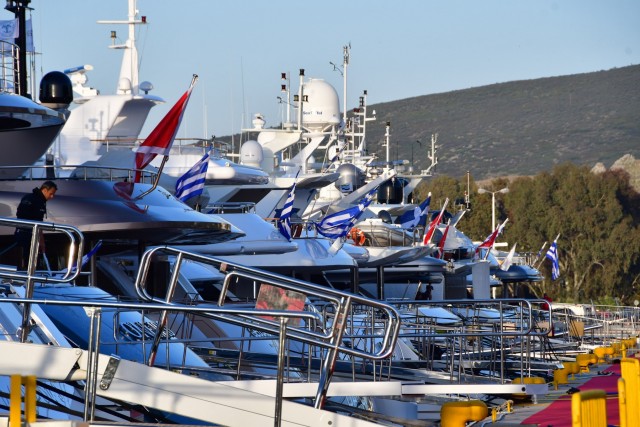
479;359;620;427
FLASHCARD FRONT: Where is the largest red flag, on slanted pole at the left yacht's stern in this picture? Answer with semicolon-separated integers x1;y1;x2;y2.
134;75;198;182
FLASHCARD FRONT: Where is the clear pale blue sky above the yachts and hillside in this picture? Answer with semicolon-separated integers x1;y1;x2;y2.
6;0;640;137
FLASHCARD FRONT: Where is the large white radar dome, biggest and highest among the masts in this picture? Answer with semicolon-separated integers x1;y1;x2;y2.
302;79;341;130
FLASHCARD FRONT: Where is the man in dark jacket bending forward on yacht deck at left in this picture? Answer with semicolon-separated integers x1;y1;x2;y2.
15;181;58;269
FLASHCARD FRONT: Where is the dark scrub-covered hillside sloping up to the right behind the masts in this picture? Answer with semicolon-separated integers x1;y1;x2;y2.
367;65;640;180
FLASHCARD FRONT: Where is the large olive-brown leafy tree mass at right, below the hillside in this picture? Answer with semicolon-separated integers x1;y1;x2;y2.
505;164;640;301
